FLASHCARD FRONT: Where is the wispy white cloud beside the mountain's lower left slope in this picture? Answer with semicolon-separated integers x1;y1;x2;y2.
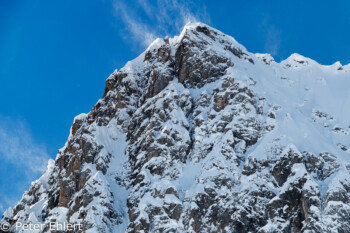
0;116;49;214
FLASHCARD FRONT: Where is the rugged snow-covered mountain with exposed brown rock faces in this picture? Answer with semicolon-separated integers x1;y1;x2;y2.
2;23;350;233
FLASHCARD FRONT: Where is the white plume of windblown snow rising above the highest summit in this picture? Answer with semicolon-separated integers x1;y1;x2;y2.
114;0;210;47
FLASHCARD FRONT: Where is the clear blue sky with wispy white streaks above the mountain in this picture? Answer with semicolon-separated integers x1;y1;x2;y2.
0;0;350;215
